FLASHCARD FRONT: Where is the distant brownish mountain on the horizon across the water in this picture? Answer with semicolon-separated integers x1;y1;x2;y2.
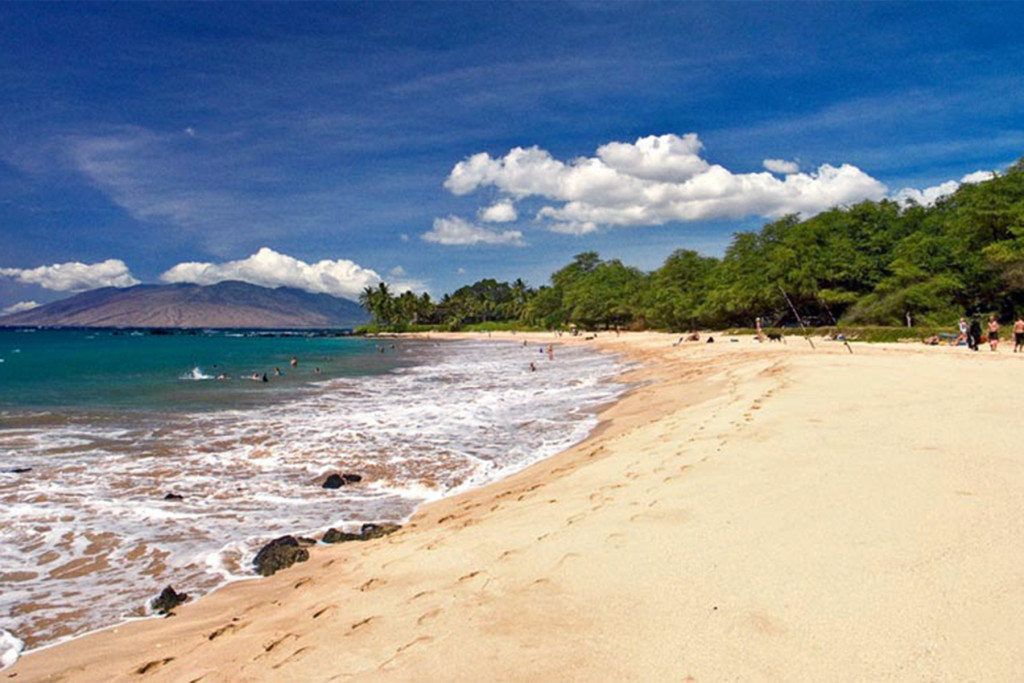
0;282;368;329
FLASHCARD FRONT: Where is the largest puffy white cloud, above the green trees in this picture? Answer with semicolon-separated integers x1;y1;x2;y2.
444;133;887;234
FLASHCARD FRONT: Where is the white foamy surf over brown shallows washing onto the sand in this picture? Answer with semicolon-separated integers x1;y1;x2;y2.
0;342;623;648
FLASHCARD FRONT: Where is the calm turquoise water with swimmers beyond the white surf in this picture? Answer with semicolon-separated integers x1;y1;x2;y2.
0;330;403;412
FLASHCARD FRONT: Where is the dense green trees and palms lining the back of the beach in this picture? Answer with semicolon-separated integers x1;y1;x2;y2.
360;159;1024;331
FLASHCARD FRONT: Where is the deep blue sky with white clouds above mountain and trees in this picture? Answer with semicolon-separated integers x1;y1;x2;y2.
0;2;1024;311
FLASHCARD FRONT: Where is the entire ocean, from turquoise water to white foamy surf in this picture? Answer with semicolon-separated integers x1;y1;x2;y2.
0;330;625;664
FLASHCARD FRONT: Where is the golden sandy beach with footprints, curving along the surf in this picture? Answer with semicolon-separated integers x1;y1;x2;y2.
8;334;1024;681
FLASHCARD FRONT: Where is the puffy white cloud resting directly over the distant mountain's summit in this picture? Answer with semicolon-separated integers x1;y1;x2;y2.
160;247;382;300
